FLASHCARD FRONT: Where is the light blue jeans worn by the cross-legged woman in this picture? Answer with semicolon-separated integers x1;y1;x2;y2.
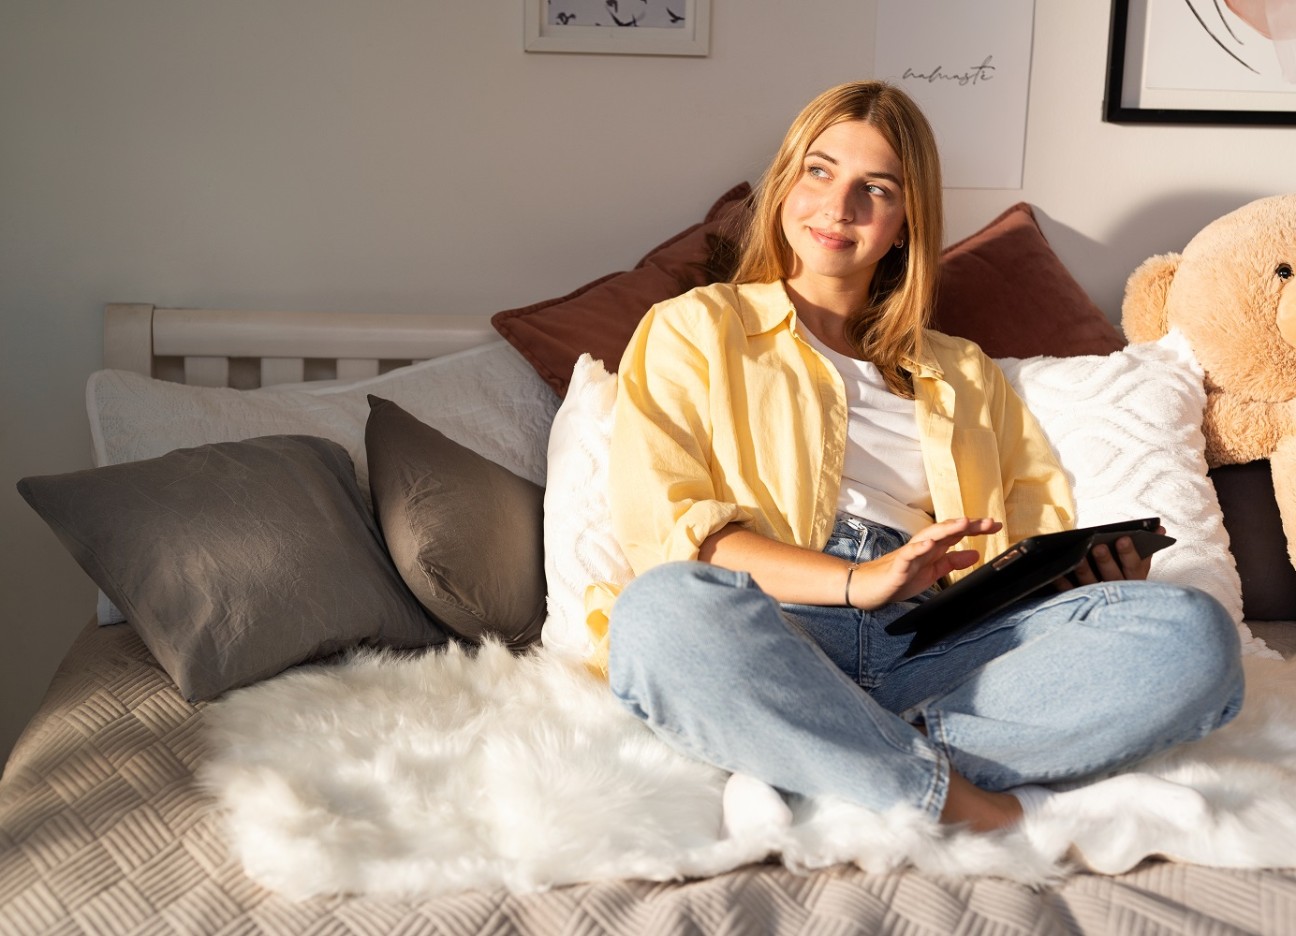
609;517;1243;817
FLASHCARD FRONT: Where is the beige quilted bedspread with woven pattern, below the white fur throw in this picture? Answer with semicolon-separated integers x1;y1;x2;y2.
0;625;1296;936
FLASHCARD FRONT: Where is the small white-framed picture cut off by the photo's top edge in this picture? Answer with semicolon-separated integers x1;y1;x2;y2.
524;0;712;56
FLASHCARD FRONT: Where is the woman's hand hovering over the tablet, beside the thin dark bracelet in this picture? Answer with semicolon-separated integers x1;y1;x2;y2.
848;517;1003;611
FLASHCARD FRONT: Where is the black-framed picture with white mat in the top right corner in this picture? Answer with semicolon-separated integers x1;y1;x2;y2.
1103;0;1296;126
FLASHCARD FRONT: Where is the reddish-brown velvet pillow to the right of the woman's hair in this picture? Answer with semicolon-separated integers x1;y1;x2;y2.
932;202;1125;358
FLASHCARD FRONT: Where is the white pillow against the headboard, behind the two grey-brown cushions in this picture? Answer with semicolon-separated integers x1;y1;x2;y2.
86;340;559;624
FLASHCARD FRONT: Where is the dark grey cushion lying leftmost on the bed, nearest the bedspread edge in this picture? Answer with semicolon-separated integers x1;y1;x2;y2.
18;436;447;701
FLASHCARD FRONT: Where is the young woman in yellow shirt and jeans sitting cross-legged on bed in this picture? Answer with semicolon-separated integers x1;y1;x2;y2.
595;82;1242;830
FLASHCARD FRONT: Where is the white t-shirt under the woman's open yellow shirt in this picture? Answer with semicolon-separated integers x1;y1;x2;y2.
797;328;933;535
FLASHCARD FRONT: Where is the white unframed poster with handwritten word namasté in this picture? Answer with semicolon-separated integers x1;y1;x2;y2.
875;0;1034;188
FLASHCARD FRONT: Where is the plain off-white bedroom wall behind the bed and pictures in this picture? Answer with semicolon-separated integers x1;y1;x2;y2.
0;0;1296;757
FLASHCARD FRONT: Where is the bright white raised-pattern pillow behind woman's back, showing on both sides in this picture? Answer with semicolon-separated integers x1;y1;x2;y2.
543;332;1262;652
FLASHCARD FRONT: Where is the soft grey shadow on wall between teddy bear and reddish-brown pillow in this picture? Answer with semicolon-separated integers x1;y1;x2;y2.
1036;191;1278;328
